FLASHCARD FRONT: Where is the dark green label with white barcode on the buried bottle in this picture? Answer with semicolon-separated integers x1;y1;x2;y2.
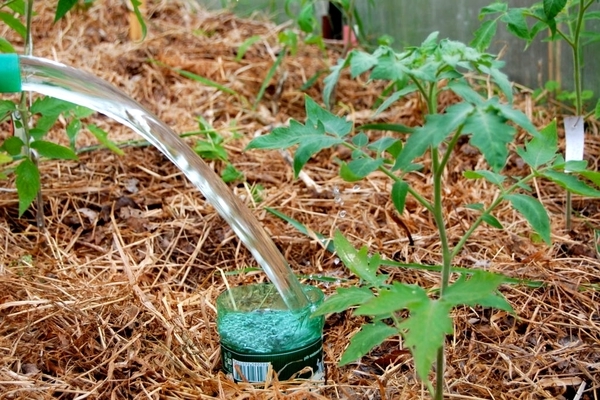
221;338;325;382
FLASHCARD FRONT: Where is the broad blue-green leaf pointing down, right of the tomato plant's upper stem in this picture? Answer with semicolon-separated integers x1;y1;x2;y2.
463;107;515;171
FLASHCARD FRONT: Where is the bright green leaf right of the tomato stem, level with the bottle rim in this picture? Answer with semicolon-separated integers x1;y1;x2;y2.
442;270;513;312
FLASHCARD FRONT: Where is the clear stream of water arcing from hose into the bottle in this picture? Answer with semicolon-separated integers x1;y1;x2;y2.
20;56;309;310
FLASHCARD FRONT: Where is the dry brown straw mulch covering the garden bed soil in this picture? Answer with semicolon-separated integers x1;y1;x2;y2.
0;1;600;399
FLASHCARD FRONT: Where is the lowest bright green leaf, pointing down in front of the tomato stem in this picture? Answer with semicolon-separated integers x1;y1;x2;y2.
398;299;453;380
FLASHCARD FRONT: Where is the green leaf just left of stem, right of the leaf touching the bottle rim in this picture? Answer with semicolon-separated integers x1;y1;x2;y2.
354;282;429;316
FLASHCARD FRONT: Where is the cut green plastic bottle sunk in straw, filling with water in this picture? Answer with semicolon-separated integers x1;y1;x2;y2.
217;283;324;382
